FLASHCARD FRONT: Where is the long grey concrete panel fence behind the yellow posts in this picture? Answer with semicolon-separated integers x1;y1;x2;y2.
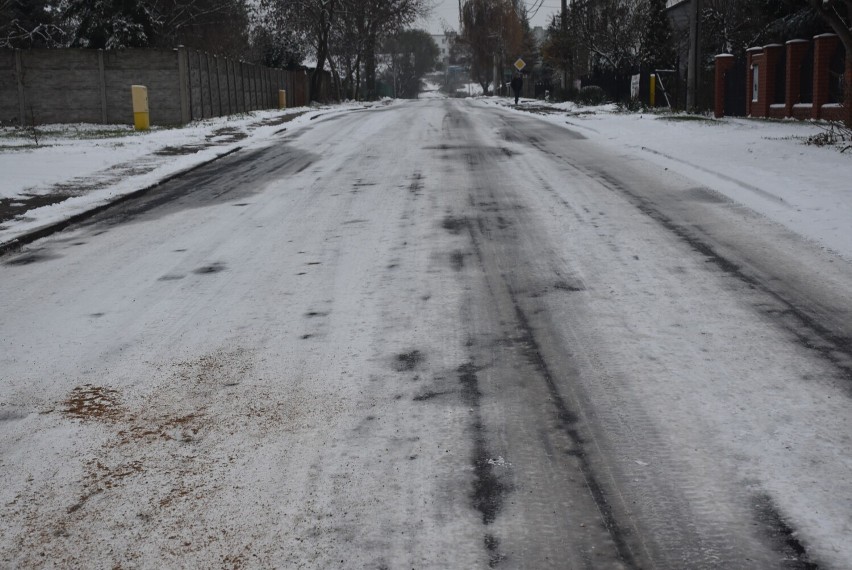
0;47;310;125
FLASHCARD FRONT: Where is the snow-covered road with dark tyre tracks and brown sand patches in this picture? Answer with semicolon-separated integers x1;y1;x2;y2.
0;100;852;569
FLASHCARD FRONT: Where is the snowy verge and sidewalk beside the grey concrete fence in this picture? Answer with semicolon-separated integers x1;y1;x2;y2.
0;102;387;249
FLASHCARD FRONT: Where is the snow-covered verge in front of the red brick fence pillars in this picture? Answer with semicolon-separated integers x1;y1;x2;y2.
486;97;852;260
